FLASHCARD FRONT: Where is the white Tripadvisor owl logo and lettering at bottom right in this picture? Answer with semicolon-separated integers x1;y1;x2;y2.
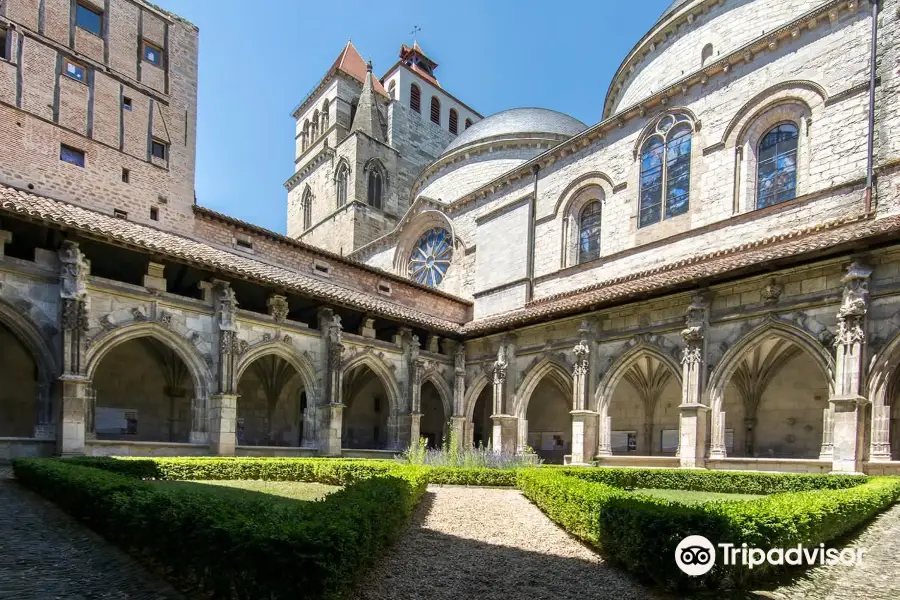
675;535;866;577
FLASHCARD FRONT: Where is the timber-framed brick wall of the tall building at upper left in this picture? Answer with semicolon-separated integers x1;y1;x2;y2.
0;0;198;232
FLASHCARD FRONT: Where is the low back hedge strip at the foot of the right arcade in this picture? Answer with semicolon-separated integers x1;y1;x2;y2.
558;467;869;495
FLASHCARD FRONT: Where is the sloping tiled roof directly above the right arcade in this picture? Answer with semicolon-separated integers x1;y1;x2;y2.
463;215;900;335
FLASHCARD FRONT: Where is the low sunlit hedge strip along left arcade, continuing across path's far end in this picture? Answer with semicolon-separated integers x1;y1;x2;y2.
68;457;516;487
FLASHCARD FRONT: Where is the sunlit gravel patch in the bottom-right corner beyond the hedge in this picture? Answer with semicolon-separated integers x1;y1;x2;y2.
763;504;900;600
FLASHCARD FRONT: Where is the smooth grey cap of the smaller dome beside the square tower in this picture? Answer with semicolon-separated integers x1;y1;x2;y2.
441;108;587;156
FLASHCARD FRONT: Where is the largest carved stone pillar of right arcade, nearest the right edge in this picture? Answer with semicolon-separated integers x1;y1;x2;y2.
829;261;872;473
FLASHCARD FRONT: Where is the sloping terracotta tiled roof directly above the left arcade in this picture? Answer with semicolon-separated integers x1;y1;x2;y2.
0;186;459;333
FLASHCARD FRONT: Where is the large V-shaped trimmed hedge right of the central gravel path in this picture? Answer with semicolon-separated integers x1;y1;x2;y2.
518;469;900;591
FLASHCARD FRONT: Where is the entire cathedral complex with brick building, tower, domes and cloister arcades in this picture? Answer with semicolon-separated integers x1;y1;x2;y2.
0;0;900;474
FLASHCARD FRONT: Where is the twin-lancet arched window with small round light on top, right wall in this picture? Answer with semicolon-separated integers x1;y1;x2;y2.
638;114;693;227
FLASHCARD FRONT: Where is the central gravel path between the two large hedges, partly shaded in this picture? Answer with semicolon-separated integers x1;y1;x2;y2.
354;487;657;600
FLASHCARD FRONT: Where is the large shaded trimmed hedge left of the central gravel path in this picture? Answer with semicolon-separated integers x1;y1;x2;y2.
13;459;427;600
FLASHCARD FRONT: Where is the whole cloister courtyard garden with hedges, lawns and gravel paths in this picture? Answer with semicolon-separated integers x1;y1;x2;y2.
0;458;900;600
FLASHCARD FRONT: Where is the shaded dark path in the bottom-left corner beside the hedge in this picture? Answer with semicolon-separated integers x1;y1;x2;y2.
0;467;182;600
